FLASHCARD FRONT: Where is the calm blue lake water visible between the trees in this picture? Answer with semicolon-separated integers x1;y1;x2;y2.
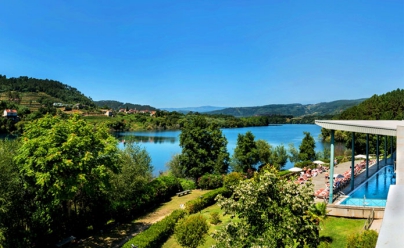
115;124;324;175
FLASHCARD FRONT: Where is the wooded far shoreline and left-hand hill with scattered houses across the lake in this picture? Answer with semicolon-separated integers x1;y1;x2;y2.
0;75;361;135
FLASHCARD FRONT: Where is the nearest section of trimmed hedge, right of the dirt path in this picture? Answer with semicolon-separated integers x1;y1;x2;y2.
123;209;185;248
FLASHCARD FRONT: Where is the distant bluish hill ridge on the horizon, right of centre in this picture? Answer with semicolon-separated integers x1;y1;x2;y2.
208;99;365;117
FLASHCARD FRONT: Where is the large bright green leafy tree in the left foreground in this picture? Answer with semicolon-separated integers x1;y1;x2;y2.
15;115;118;242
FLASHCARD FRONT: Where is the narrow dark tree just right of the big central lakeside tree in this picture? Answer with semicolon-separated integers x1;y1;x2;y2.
233;131;262;172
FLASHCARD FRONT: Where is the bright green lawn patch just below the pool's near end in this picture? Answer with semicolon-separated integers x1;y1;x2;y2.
320;217;365;248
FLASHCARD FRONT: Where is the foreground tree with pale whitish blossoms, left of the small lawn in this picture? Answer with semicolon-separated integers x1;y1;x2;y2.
213;167;319;247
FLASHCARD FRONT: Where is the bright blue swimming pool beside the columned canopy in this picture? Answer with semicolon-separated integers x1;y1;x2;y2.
340;165;396;207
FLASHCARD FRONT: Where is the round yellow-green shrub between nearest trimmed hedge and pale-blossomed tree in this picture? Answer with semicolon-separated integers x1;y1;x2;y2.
175;214;209;248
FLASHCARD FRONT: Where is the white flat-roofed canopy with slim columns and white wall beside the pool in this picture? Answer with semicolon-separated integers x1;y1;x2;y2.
315;120;404;247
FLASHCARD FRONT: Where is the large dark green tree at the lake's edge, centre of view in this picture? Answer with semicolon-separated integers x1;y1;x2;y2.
180;116;229;180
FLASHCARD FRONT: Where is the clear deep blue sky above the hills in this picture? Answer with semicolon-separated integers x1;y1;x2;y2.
0;0;404;108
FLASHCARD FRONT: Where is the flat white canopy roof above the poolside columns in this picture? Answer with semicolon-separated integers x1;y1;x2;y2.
315;120;404;136
